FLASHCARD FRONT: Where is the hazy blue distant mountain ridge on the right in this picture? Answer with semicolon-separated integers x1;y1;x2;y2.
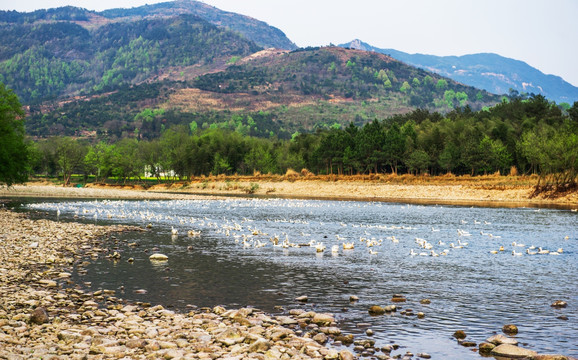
340;40;578;104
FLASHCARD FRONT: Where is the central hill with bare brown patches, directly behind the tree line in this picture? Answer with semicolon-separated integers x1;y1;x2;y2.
27;47;501;140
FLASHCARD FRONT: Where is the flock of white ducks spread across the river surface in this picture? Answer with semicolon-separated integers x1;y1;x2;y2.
30;200;569;257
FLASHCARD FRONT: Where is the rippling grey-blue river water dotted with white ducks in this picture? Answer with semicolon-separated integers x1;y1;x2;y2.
18;198;578;359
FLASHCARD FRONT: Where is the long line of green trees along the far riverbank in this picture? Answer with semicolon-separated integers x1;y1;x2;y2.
29;95;578;191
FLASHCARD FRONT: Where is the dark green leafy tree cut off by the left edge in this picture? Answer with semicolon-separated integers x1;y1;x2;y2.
0;83;29;186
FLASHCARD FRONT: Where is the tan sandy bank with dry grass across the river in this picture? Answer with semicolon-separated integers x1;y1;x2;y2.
0;176;578;208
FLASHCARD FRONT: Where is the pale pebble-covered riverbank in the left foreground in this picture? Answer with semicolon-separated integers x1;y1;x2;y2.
0;210;354;359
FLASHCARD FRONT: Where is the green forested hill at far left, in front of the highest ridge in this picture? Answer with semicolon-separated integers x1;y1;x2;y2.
0;11;260;103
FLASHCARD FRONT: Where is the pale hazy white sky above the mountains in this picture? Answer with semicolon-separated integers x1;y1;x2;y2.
0;0;578;86
